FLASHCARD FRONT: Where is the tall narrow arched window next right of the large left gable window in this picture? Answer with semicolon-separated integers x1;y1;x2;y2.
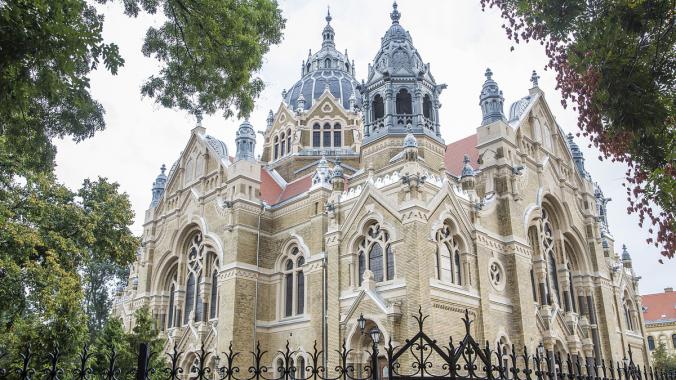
282;246;305;317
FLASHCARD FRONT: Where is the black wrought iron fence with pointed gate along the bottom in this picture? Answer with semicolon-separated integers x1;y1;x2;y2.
0;311;676;380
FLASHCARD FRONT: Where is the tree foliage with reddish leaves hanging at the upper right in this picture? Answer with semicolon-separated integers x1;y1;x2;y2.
481;0;676;261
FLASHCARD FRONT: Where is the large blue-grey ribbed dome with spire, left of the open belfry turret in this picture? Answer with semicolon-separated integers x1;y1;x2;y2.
283;9;361;110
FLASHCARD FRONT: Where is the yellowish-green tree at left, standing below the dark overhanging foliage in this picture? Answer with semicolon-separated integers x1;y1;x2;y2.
0;136;138;355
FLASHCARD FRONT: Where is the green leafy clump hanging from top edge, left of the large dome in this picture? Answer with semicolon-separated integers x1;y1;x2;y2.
135;0;285;118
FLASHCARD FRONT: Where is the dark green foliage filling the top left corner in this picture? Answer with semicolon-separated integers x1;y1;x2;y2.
0;0;124;170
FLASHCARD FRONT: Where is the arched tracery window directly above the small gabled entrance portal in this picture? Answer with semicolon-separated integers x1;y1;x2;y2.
358;223;395;285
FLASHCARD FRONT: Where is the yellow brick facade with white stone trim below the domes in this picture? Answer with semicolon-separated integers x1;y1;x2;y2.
115;2;646;376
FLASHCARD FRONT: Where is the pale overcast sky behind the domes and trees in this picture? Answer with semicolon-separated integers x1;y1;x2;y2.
56;0;676;294
